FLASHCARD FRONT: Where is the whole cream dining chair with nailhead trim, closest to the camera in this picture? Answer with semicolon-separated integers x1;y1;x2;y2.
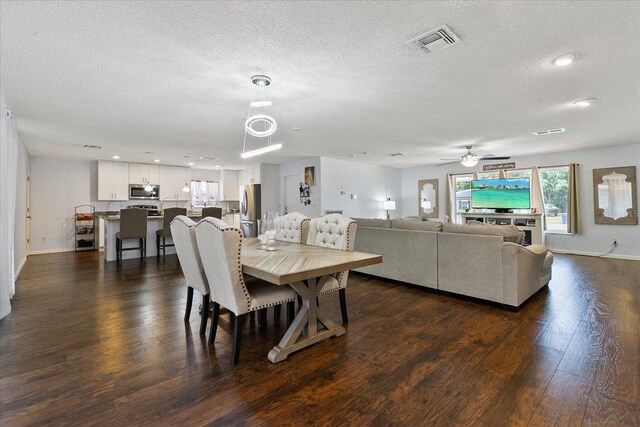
195;217;296;365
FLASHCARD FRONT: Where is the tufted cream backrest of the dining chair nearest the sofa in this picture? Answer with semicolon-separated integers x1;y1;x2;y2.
307;214;358;288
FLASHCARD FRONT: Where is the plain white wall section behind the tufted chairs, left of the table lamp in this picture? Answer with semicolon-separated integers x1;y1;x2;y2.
316;157;402;218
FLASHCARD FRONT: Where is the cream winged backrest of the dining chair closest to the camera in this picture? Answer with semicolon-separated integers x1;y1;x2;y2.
195;217;251;315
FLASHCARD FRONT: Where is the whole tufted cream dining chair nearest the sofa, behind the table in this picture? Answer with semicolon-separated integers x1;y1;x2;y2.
307;214;357;324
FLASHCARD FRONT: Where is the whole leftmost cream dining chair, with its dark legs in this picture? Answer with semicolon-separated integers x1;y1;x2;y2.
170;215;210;335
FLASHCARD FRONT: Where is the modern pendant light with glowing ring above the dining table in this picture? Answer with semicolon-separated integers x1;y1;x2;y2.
240;74;282;159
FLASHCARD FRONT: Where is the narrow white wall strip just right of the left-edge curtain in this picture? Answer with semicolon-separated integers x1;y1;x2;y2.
13;140;29;278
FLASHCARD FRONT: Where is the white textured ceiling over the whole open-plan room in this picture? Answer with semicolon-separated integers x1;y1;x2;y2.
0;1;640;168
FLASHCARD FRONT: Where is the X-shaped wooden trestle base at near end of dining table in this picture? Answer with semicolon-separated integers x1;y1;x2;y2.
268;279;346;363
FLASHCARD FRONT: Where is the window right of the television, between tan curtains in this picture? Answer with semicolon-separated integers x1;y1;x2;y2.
539;166;569;233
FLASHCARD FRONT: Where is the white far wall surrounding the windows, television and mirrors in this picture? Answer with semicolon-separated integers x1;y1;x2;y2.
402;144;640;259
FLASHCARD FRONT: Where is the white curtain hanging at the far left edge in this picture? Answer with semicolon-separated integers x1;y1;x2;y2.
0;98;21;319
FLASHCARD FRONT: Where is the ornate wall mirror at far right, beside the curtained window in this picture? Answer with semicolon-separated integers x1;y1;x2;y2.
593;166;638;225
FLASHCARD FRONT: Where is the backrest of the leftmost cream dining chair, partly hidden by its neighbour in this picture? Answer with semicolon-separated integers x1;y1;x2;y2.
170;215;209;295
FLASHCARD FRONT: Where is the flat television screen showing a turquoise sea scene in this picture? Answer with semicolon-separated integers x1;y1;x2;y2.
471;178;530;209
